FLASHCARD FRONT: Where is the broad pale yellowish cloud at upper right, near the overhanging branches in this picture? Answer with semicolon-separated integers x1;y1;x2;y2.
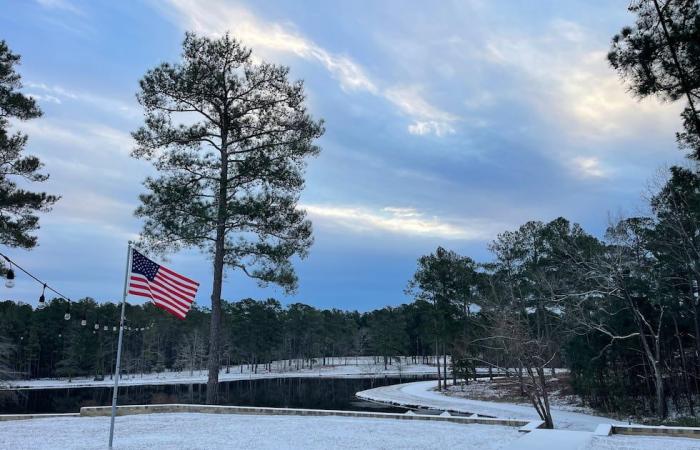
482;19;677;140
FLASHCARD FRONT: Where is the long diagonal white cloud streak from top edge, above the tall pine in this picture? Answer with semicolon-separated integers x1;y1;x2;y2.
159;0;458;137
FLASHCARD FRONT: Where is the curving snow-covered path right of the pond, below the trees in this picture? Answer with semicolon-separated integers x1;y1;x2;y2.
357;381;618;431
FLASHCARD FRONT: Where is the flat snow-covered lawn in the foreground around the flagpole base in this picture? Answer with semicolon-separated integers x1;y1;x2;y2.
0;413;520;450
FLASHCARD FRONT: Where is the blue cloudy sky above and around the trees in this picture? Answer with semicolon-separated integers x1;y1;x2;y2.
0;0;682;311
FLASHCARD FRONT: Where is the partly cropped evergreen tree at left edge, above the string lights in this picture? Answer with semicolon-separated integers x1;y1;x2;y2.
0;41;58;253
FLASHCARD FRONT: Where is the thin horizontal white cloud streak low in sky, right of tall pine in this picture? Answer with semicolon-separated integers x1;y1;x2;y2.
301;204;503;241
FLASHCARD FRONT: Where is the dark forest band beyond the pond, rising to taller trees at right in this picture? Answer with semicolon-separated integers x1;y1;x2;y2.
0;167;700;424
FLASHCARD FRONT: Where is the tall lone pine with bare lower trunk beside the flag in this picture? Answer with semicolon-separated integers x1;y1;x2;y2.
133;33;323;404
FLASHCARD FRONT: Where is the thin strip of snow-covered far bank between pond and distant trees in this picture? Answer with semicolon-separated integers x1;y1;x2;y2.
5;356;436;389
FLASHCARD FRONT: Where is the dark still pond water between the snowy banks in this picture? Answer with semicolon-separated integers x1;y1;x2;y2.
0;376;434;414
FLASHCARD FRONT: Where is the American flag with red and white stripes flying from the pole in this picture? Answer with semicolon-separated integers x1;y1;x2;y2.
129;249;199;319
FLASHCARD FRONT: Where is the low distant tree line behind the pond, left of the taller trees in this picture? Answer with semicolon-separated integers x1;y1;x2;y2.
0;298;431;380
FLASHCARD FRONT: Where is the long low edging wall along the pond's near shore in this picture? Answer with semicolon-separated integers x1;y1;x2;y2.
80;403;530;427
